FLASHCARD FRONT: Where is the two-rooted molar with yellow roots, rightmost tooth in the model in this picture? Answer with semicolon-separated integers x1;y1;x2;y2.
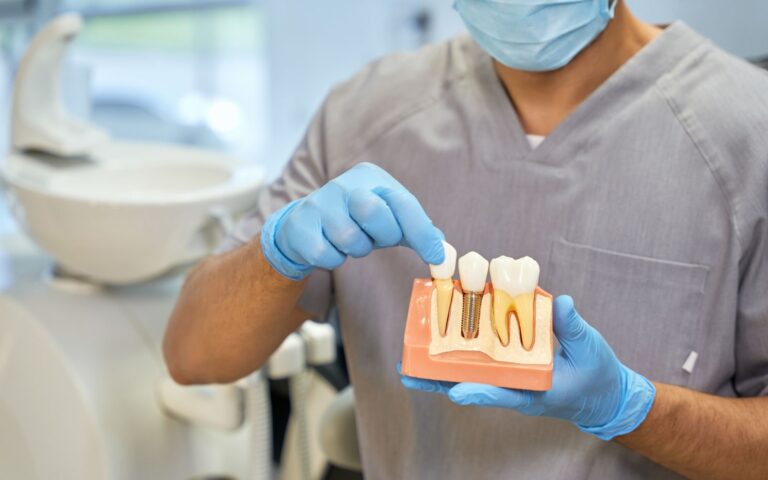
491;257;540;350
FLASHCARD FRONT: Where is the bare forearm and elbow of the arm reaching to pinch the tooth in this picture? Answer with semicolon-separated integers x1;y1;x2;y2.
163;237;307;384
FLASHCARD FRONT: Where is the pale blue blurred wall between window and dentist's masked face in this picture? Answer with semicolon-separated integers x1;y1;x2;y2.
261;0;461;176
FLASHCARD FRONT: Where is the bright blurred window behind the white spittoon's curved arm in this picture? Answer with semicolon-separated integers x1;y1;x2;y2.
69;0;266;158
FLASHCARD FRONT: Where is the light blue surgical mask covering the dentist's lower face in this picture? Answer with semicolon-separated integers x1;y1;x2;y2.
453;0;618;72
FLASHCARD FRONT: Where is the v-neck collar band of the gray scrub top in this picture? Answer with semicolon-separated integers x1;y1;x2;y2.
473;22;706;168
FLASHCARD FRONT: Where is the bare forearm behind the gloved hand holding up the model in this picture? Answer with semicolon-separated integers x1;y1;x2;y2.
616;384;768;479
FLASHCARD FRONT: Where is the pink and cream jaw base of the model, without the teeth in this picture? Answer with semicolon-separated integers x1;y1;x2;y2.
402;279;554;391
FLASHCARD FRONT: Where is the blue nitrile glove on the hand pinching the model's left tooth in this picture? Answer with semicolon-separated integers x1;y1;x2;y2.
261;163;445;280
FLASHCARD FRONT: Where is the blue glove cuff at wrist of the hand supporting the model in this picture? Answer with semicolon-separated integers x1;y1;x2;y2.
577;366;656;441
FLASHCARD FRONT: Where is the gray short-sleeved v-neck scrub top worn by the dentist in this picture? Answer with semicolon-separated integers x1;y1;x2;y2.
222;23;768;480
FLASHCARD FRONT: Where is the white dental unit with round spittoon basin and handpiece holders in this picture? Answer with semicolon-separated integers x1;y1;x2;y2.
0;15;364;480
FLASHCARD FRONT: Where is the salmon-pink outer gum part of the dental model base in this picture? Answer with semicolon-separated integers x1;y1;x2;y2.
402;279;554;391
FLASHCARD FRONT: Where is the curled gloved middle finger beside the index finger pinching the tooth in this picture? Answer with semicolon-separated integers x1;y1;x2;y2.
347;188;403;247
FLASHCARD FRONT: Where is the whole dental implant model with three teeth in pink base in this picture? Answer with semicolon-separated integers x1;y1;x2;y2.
402;243;554;391
